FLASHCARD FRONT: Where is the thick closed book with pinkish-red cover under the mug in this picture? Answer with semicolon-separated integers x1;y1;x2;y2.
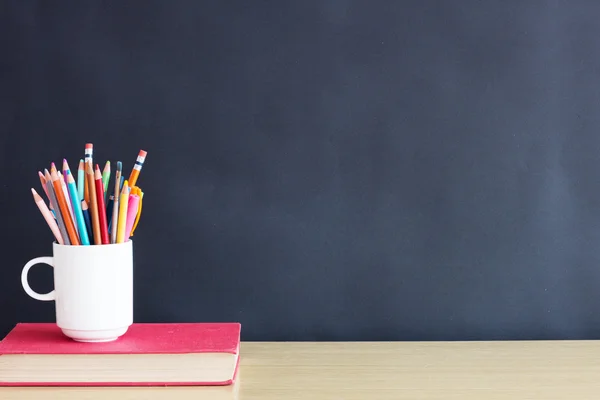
0;323;241;386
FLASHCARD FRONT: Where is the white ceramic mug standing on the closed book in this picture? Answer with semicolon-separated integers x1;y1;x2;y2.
21;240;133;342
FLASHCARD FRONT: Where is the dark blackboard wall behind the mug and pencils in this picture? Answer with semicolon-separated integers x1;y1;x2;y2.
0;0;600;340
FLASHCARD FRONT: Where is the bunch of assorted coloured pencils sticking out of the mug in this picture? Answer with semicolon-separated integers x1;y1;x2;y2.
31;143;147;246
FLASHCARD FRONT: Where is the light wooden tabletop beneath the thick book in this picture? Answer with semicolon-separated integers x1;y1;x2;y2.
0;341;600;400
